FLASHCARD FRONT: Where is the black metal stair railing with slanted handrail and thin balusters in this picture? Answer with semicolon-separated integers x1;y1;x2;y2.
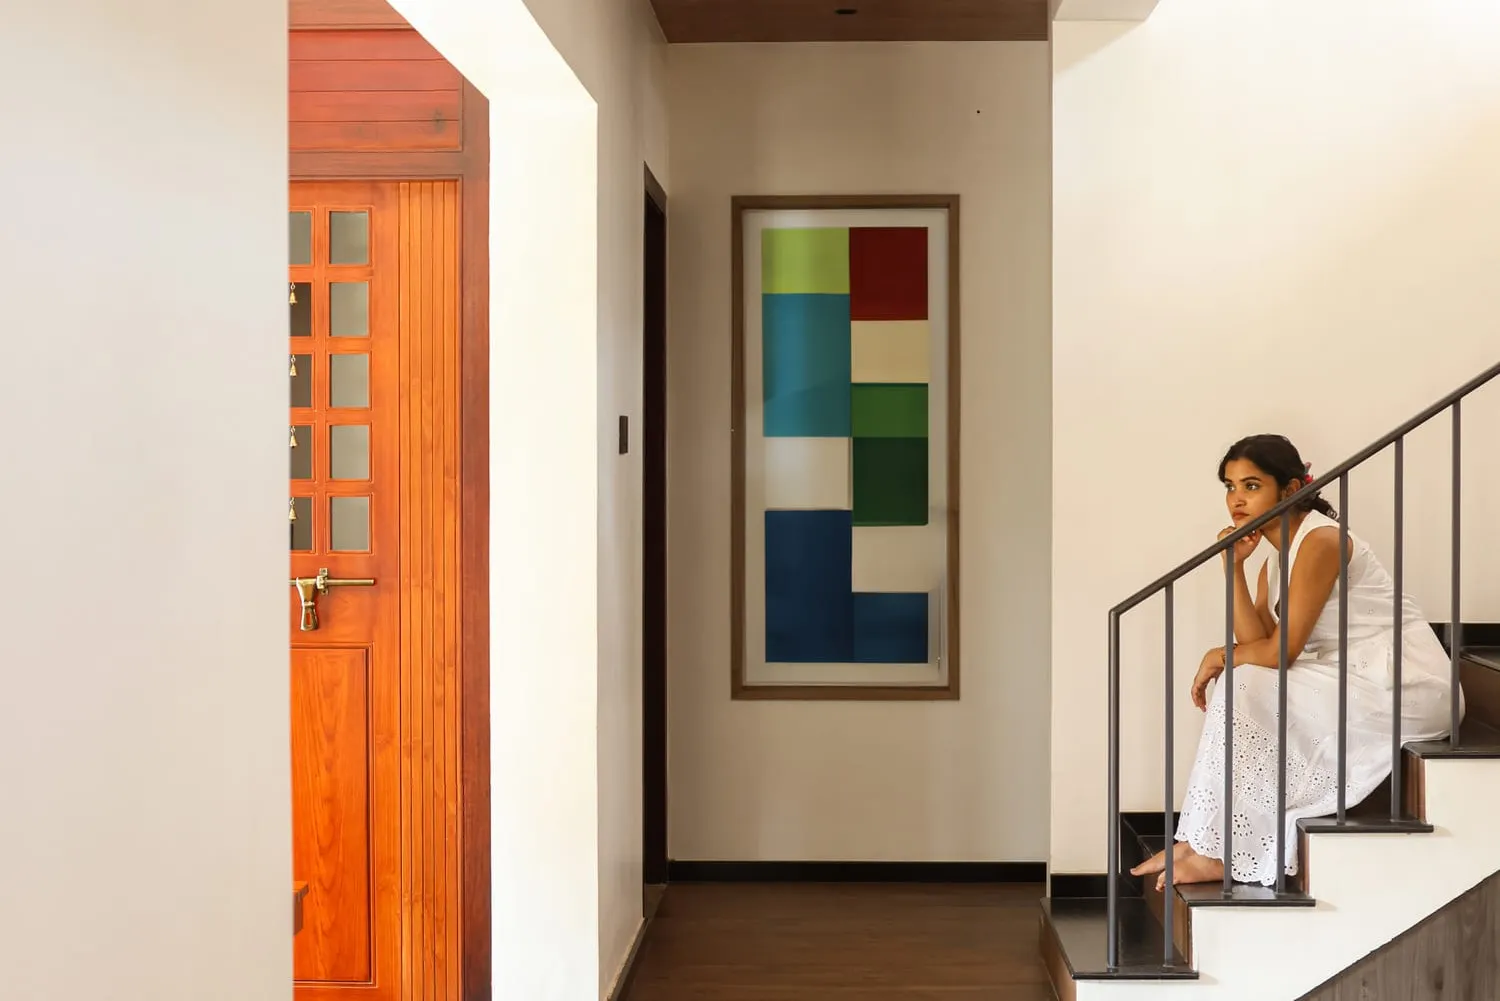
1107;365;1500;969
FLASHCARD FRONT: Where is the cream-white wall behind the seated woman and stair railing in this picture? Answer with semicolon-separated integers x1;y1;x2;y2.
1052;0;1500;872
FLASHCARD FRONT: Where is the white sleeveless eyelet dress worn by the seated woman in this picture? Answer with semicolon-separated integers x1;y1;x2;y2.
1176;512;1461;885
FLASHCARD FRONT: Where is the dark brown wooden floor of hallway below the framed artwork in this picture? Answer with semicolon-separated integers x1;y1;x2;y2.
626;884;1053;1001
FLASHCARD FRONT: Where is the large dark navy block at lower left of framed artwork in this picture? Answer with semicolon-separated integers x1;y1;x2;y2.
765;510;855;663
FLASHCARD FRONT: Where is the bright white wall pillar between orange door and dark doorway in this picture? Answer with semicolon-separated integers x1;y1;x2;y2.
396;0;669;999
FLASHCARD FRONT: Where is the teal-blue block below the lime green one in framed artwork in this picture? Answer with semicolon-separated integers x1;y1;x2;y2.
761;293;852;438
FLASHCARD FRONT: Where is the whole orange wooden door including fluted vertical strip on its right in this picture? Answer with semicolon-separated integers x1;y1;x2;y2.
288;182;461;1001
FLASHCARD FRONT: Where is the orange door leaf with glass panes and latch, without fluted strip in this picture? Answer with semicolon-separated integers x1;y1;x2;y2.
288;182;402;1001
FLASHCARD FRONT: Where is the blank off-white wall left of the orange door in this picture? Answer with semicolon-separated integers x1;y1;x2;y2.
0;0;293;1001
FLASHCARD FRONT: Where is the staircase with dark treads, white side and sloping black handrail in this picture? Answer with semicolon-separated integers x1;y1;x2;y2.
1041;365;1500;1001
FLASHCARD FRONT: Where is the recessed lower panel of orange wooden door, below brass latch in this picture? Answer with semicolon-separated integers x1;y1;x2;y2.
291;645;374;983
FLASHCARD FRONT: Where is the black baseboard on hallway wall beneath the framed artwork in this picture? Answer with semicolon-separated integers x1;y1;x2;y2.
668;860;1047;882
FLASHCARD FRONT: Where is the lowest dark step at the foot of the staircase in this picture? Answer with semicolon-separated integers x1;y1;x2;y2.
1041;897;1199;980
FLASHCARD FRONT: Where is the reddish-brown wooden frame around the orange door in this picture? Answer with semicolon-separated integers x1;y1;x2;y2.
288;0;494;1001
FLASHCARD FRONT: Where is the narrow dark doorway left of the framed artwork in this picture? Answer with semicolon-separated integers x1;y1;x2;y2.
641;168;668;885
